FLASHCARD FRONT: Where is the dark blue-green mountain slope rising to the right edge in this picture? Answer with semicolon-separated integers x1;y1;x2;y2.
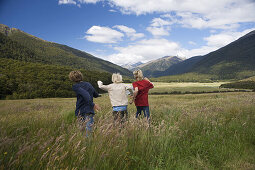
156;31;255;79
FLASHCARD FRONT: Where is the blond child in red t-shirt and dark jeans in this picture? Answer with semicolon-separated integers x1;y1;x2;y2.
131;70;154;121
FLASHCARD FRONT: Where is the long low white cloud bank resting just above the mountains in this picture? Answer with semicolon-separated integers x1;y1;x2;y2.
94;28;255;65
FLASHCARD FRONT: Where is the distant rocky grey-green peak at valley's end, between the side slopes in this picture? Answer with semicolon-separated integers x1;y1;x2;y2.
137;56;183;77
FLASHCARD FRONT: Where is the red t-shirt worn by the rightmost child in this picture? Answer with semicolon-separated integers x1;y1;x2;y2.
133;80;153;106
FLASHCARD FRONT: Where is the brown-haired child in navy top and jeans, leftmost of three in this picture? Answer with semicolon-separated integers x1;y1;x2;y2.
69;71;100;136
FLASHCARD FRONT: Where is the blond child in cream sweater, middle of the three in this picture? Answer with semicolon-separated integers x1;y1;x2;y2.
97;73;133;123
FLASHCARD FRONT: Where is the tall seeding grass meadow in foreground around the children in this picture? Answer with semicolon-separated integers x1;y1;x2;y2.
0;83;255;170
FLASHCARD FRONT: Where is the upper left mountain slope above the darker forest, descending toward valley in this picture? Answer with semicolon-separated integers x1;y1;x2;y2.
0;24;132;76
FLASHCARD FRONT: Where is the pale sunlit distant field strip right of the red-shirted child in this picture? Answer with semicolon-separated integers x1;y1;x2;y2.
150;82;250;94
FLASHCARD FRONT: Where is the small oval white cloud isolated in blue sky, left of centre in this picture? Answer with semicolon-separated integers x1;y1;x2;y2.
84;26;124;43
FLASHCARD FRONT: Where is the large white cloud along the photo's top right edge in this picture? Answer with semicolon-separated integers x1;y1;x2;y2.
110;0;255;29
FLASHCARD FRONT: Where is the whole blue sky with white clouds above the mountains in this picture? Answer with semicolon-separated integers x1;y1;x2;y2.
0;0;255;65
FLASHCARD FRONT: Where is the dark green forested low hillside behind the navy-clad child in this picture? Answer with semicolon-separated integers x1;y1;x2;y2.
0;58;111;99
